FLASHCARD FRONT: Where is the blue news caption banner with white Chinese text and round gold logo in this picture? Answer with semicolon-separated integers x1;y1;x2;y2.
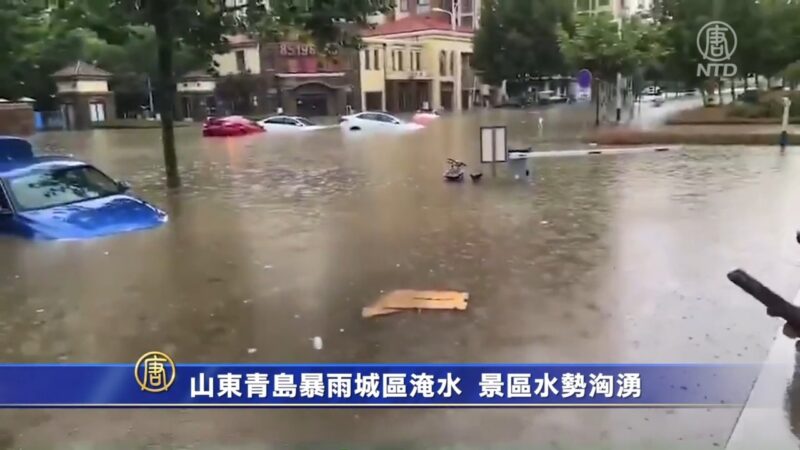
0;352;759;408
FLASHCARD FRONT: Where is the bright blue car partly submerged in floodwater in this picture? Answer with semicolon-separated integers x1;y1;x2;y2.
0;136;167;240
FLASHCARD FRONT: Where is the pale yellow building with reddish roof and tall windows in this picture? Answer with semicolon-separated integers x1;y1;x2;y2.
359;16;480;112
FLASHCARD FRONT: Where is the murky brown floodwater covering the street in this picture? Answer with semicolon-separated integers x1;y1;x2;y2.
0;110;800;449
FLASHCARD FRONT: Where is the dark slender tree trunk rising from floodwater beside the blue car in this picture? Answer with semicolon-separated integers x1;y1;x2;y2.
150;0;181;188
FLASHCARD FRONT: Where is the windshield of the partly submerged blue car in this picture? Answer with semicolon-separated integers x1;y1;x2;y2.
8;166;121;211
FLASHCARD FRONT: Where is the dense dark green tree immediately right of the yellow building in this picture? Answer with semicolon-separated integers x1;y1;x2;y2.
474;0;572;89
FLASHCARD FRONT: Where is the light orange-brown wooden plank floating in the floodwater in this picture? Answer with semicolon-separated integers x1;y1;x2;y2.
361;289;469;318
